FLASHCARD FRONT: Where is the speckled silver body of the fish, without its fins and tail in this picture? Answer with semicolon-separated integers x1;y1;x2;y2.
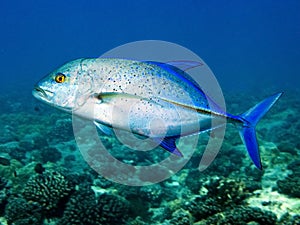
35;58;220;137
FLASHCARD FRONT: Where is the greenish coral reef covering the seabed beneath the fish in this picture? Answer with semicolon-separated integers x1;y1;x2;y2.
0;90;300;225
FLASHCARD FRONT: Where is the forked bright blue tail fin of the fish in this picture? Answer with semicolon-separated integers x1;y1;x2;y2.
239;93;282;170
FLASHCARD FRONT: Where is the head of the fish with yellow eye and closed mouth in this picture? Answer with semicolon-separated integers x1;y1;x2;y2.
32;59;83;111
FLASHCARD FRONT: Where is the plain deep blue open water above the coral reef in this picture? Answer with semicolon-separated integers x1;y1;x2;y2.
0;0;300;92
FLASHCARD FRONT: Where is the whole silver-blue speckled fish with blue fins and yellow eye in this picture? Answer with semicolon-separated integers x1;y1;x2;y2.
32;58;283;170
